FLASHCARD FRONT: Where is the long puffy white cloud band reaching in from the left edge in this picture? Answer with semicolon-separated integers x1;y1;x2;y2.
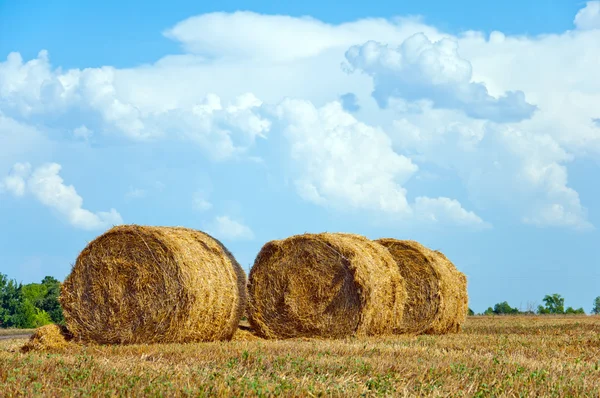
0;51;269;160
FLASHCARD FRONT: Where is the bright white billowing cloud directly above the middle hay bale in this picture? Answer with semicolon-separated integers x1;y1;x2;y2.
277;99;417;213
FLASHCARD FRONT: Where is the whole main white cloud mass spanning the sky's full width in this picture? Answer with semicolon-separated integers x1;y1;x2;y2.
0;2;600;228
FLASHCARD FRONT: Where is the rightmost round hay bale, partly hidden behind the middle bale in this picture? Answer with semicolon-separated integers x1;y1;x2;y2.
376;238;468;334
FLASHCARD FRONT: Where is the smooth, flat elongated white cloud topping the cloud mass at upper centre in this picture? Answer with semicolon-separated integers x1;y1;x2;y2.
164;11;436;62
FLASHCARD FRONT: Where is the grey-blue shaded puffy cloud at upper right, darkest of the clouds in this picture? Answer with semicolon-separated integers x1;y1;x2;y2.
346;33;536;122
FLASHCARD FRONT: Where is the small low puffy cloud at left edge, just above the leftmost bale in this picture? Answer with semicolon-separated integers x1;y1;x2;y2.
2;163;123;230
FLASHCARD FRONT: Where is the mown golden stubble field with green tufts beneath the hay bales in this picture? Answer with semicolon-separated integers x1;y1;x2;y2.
0;316;600;397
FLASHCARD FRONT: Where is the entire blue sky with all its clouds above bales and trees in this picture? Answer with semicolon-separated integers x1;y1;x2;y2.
0;1;600;311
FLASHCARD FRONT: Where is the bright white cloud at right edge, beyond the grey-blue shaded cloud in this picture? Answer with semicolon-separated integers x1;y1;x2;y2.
459;24;600;157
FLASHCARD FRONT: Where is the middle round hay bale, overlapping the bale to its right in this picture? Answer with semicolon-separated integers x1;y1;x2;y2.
248;233;406;338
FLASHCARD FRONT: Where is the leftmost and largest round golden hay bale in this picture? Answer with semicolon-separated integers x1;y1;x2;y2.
60;225;246;344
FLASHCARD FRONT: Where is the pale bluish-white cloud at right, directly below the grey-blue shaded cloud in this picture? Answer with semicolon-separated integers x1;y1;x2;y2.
391;102;591;229
